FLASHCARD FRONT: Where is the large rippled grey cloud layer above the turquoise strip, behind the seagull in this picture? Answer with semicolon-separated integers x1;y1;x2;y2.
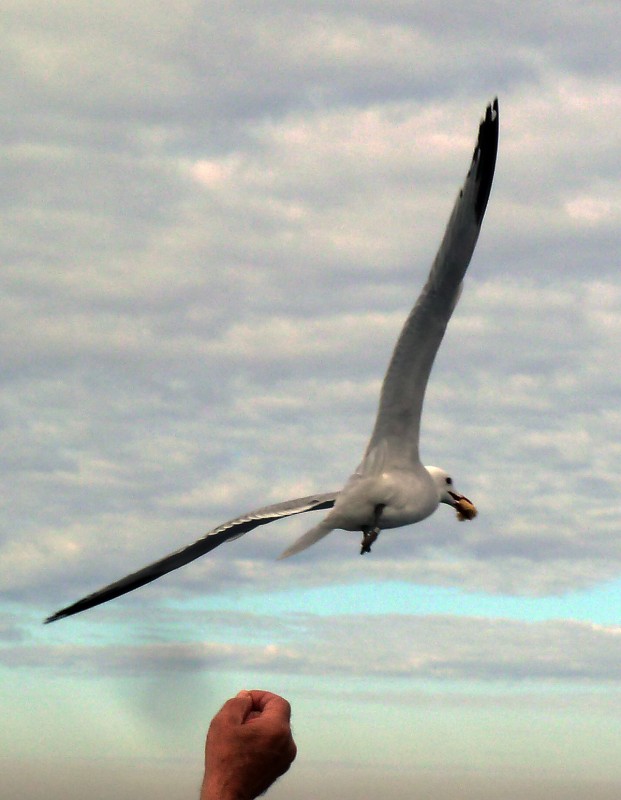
0;3;621;603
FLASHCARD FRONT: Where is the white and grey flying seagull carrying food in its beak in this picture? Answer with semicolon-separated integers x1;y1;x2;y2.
45;99;499;623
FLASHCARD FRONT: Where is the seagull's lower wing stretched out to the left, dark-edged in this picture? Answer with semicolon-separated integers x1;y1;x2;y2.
45;492;338;624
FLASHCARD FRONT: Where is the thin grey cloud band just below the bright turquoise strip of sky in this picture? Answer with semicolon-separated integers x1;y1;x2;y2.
7;612;621;685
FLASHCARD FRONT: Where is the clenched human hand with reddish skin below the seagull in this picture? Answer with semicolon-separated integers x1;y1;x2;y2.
201;690;297;800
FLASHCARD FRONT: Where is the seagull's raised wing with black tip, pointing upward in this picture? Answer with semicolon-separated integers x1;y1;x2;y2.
361;100;498;470
